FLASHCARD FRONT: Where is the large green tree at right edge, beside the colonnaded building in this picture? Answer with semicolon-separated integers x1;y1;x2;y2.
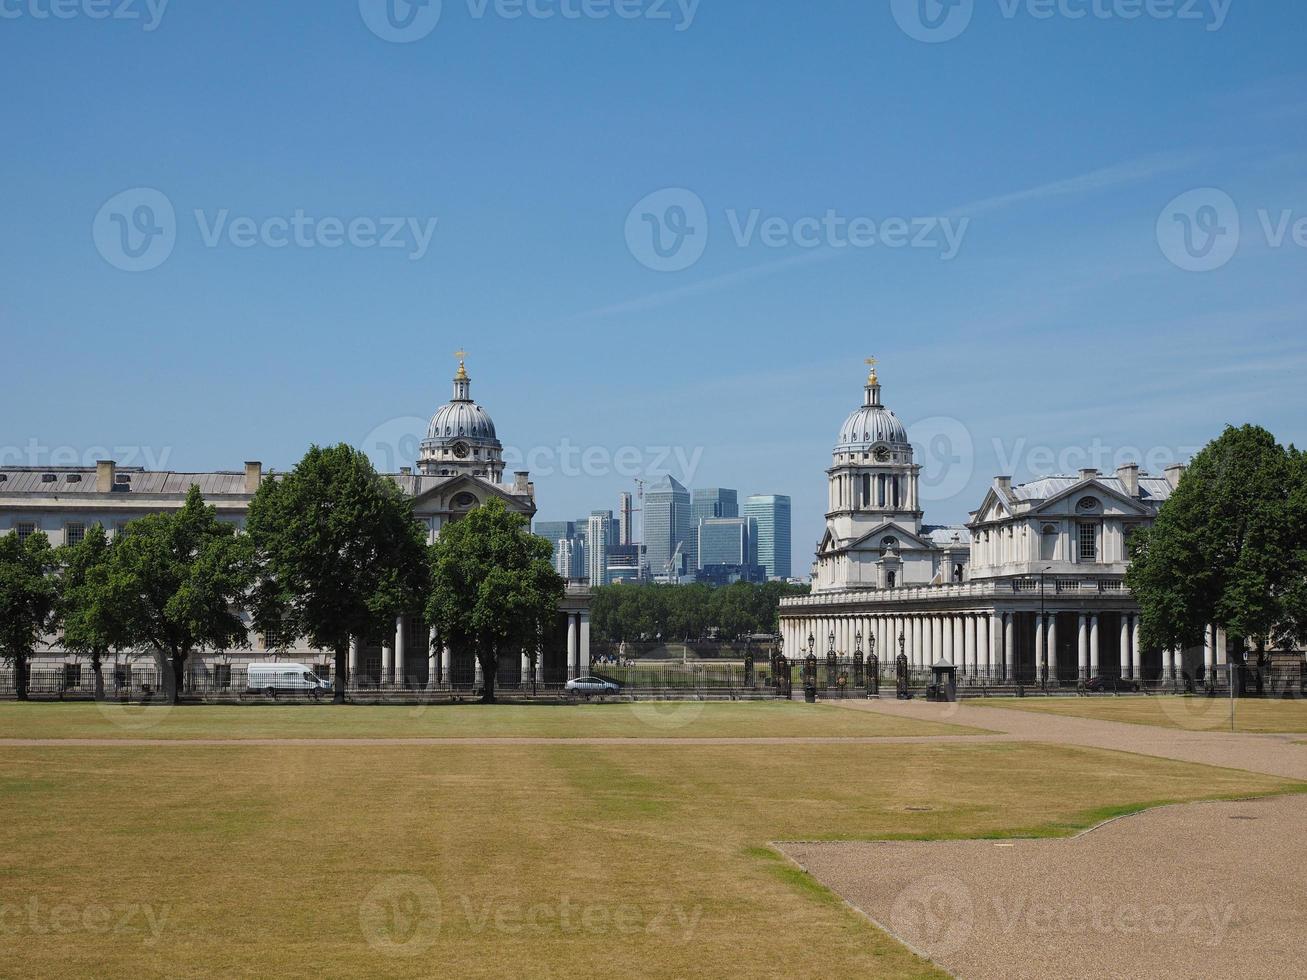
1127;426;1307;660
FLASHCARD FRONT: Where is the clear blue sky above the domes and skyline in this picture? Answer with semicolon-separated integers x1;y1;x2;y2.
0;0;1307;571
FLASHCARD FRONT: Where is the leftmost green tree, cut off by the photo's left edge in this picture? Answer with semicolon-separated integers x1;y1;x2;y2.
0;531;59;700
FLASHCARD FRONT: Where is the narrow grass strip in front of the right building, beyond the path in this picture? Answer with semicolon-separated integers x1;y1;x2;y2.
967;694;1307;733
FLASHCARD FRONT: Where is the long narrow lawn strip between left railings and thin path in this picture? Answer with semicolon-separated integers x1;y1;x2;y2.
0;702;979;738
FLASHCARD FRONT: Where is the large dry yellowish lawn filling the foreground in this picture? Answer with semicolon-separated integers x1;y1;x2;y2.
0;706;1307;977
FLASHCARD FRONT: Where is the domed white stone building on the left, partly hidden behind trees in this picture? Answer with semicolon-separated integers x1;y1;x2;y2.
0;359;589;690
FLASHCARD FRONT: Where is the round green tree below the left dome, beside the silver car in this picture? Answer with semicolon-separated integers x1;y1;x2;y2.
426;499;566;702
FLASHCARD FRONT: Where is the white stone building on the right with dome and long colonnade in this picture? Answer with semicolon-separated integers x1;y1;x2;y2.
780;371;1226;686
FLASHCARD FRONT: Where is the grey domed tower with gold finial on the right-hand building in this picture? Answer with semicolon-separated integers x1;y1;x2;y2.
826;358;921;547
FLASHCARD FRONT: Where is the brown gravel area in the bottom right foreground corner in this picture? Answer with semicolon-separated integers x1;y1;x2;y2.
779;799;1307;980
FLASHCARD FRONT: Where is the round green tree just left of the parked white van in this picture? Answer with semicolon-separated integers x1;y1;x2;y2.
106;486;254;704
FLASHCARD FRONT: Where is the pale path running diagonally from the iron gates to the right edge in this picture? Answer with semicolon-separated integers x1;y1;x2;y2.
831;699;1307;781
